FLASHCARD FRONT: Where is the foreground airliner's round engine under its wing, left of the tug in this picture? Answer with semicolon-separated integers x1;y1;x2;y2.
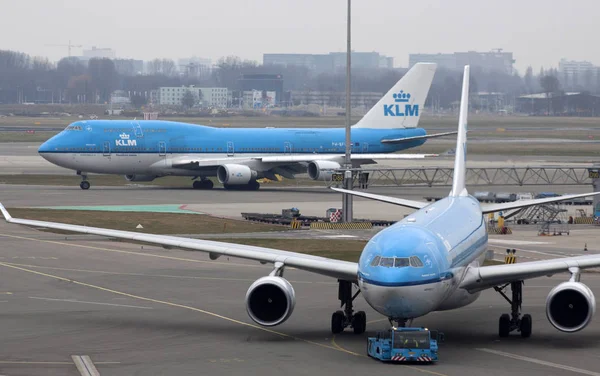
246;276;296;326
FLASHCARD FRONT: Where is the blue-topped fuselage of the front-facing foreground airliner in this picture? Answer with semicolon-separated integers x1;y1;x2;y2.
358;196;488;319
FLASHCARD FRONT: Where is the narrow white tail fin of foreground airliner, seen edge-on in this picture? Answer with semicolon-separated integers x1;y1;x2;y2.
450;65;469;196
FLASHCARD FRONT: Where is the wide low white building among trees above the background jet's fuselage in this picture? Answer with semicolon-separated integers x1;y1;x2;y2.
158;86;230;108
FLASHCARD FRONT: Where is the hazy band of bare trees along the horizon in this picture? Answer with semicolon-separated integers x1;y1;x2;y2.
0;50;600;108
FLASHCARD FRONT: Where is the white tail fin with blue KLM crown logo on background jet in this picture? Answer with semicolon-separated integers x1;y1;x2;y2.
353;63;437;129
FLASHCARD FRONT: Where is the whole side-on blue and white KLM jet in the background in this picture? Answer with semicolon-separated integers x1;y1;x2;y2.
38;63;456;189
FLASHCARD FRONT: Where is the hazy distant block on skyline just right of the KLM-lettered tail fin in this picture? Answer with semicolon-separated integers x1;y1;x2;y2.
408;49;515;75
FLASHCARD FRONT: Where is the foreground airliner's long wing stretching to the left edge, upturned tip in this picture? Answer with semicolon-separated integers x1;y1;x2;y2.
0;204;358;281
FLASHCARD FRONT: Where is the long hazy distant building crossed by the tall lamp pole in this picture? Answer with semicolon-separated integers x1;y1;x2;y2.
263;51;394;73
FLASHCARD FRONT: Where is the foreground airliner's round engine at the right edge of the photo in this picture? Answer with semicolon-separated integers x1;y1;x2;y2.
546;281;596;333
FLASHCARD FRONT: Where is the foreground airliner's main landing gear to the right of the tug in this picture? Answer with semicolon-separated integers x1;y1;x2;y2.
494;281;532;338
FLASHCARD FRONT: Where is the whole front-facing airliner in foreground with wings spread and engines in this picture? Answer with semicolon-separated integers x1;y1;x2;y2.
0;66;600;337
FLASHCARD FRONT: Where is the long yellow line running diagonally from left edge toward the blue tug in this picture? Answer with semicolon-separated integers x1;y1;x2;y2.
0;262;364;356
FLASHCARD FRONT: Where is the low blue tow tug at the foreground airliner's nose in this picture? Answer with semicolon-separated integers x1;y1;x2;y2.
367;327;444;363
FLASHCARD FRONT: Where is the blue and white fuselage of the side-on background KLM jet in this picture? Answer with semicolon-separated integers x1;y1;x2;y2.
38;120;426;176
